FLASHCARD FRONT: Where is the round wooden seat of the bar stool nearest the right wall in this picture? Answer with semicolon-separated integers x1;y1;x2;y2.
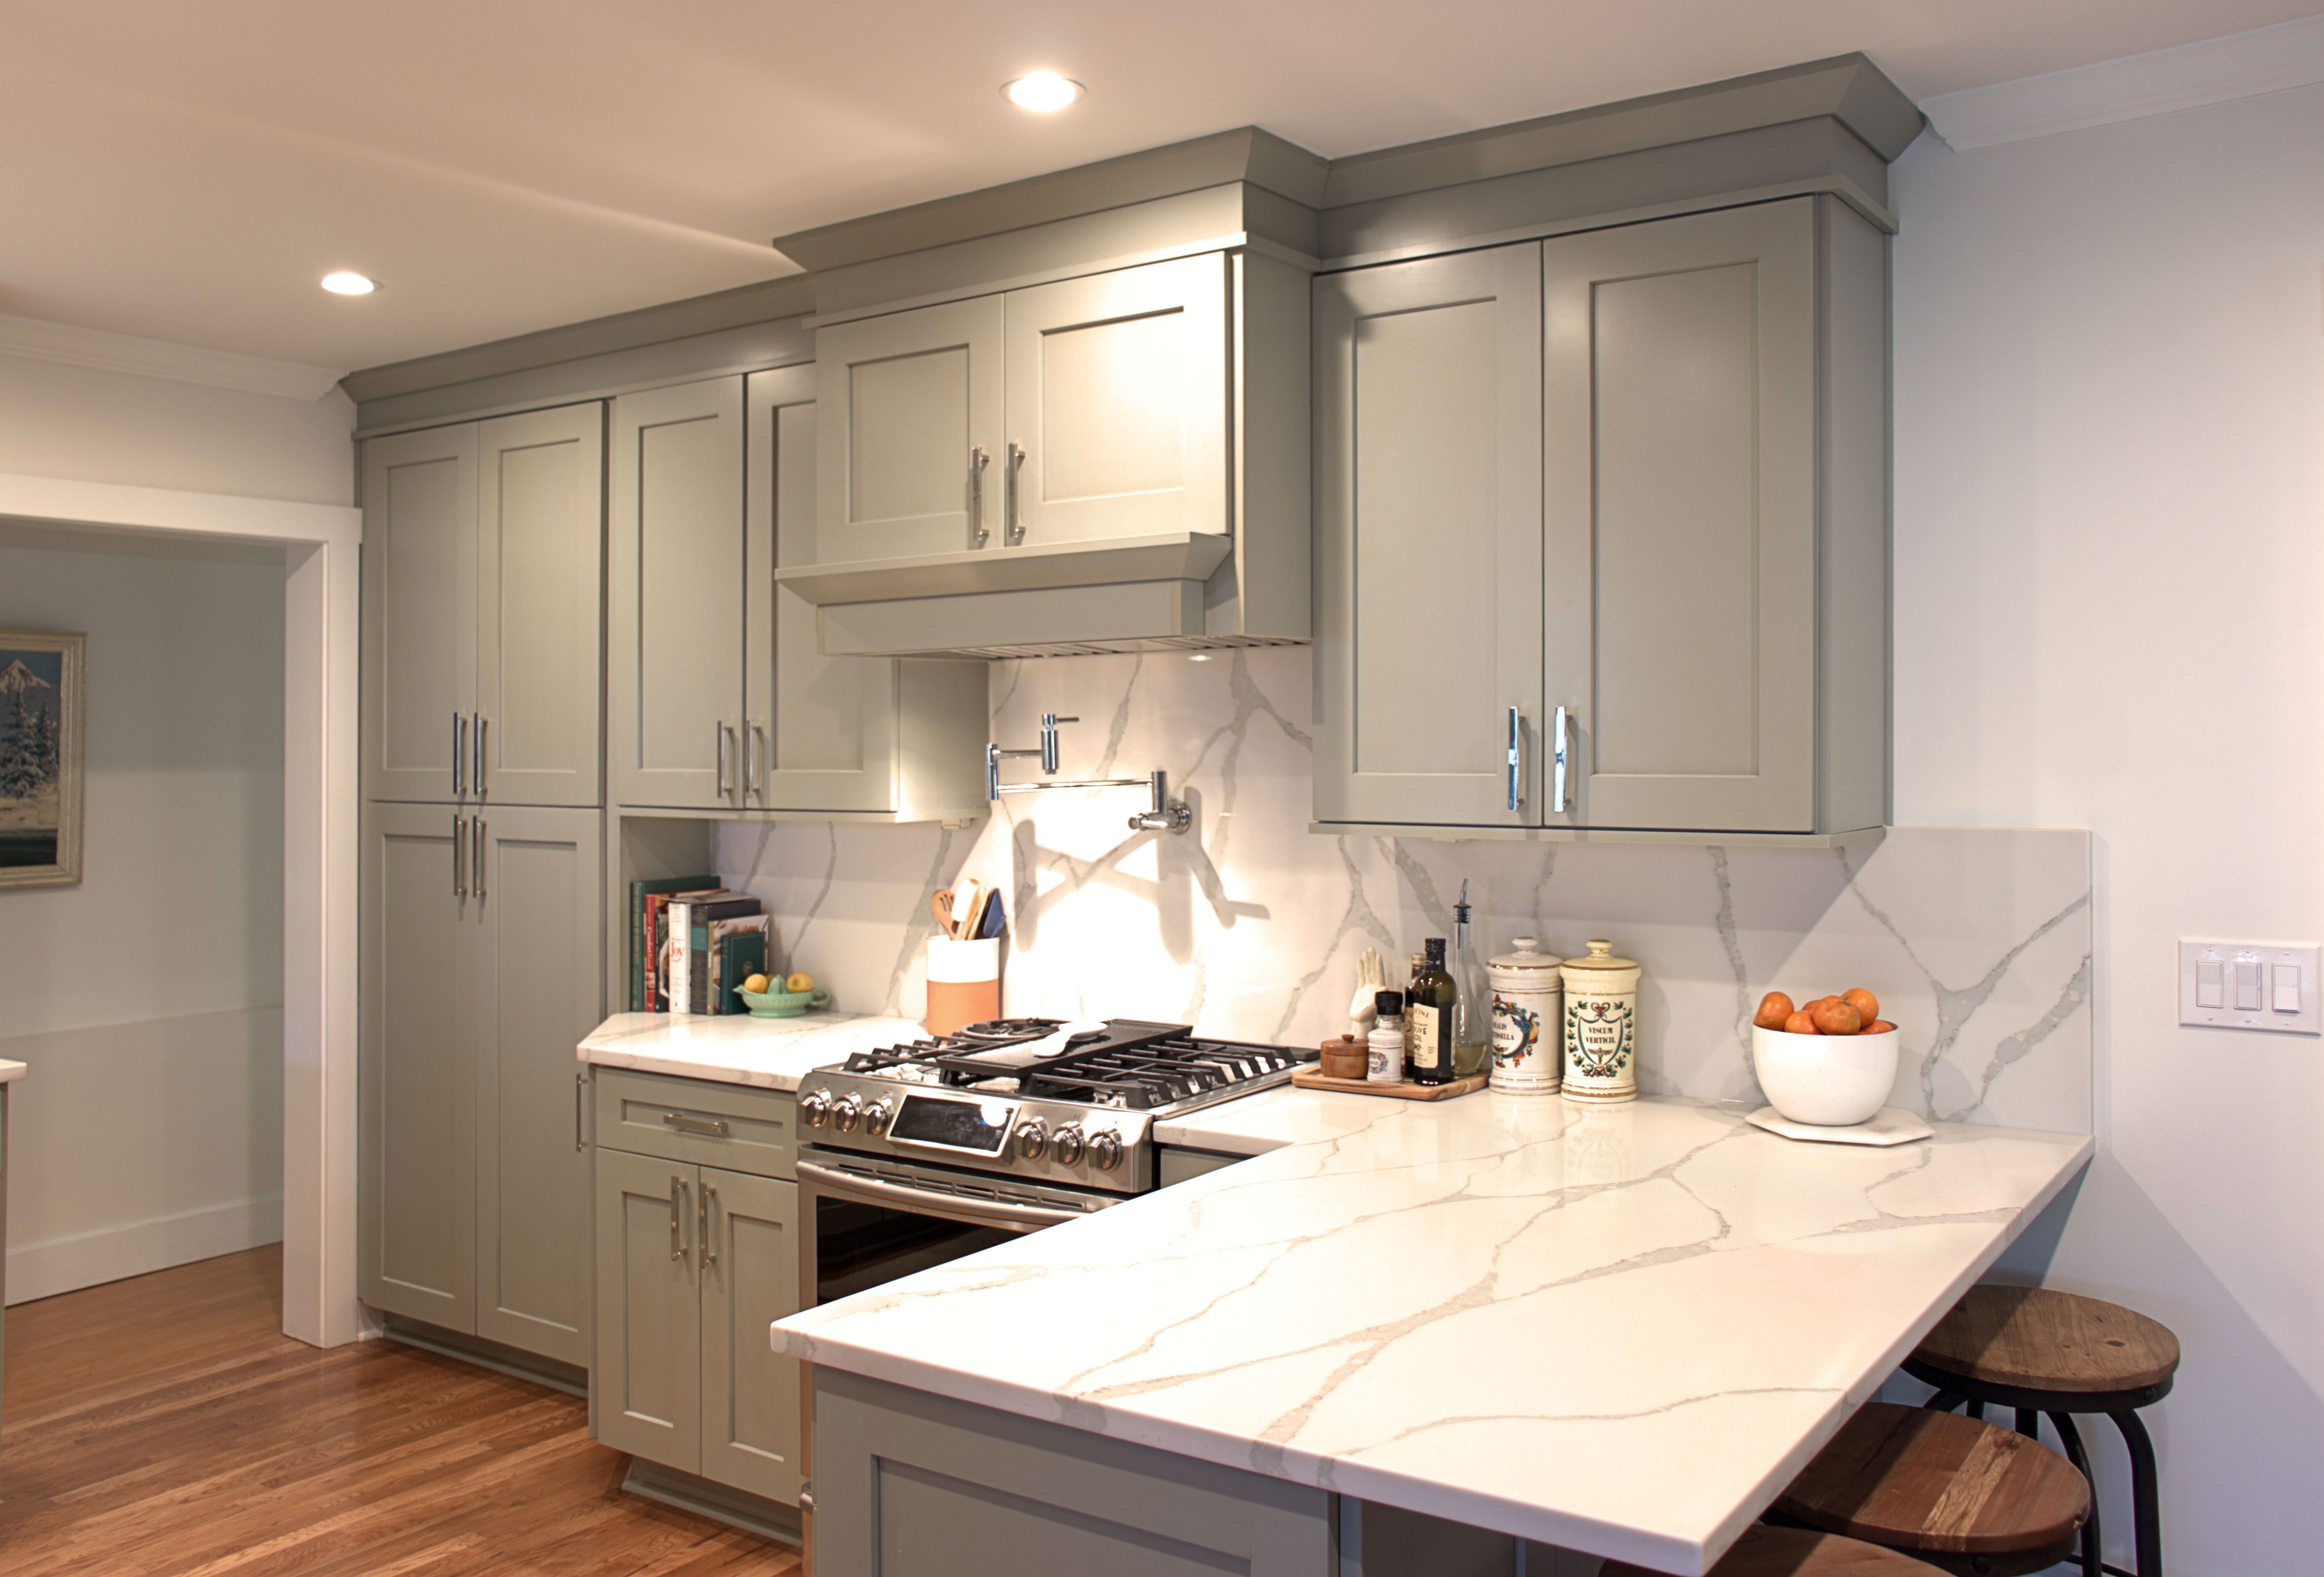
1913;1287;2177;1412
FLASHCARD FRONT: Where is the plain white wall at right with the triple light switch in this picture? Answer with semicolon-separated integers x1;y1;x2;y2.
1894;77;2324;1577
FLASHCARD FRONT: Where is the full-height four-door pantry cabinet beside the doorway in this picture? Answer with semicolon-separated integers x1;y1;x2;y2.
358;402;604;1366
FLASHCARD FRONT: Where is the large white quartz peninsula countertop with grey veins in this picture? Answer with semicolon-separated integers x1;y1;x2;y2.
771;1091;2092;1572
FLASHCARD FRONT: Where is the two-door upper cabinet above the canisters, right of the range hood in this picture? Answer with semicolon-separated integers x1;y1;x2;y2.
1315;198;1887;836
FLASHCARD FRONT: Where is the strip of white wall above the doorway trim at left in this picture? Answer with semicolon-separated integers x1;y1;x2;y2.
0;356;356;504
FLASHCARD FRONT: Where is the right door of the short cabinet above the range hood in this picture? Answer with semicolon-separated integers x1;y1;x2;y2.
999;253;1232;543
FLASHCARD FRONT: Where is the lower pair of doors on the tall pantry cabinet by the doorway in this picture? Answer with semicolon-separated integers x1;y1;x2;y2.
358;804;602;1366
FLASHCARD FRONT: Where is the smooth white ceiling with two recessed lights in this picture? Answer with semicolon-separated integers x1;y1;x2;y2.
0;0;2317;369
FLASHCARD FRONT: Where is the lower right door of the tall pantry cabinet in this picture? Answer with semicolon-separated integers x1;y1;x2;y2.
460;806;604;1366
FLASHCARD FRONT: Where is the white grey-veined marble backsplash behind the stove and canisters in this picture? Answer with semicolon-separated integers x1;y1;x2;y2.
716;648;2092;1133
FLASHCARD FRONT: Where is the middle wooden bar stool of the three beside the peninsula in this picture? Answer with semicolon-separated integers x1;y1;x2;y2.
1773;1403;2089;1577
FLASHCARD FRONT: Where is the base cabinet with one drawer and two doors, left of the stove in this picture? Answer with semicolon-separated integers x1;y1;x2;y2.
590;1071;800;1505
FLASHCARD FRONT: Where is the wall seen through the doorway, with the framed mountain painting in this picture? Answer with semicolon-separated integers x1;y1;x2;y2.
0;525;283;1303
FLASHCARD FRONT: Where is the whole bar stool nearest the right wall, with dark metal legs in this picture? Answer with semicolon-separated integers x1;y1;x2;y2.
1903;1287;2180;1577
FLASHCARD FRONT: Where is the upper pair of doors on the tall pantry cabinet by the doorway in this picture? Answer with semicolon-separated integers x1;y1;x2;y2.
363;402;604;806
